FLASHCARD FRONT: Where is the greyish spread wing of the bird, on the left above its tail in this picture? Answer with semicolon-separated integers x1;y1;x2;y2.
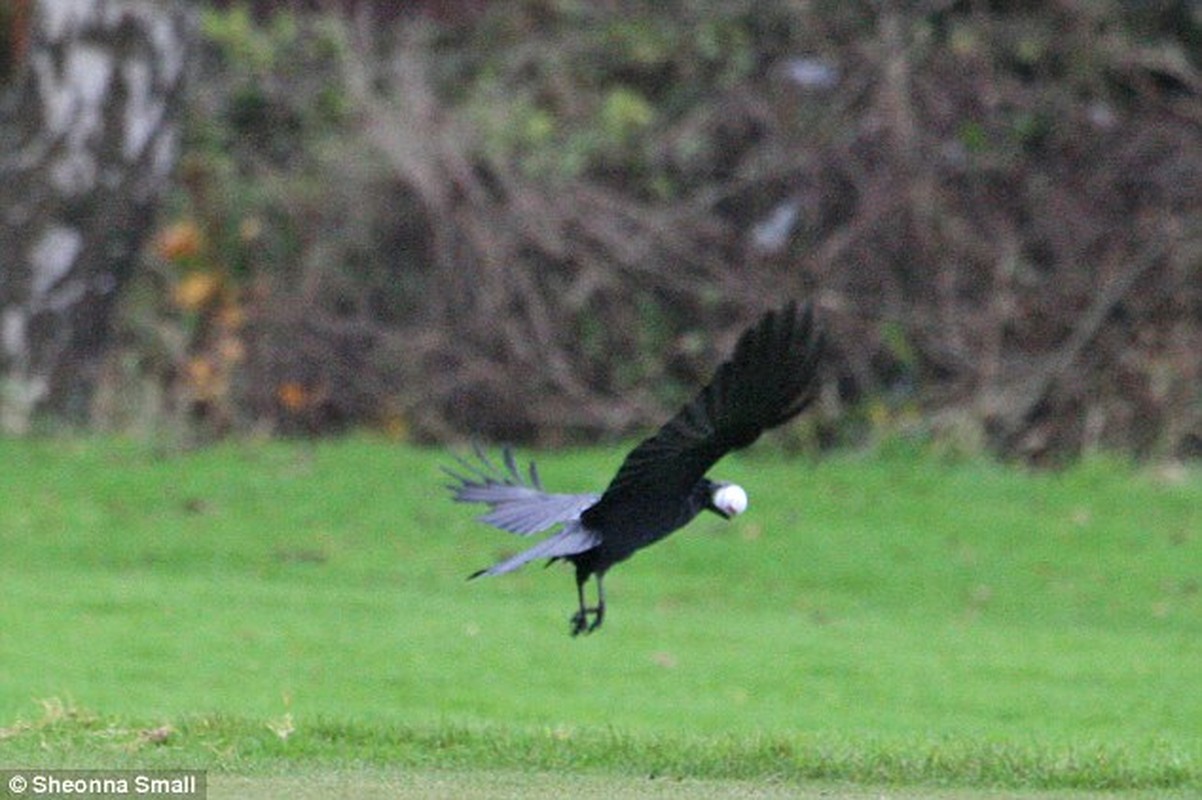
442;446;600;536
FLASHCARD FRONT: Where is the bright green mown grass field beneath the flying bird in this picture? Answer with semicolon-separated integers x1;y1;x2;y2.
0;438;1202;800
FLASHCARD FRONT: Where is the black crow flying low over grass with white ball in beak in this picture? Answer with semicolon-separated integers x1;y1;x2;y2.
444;303;823;635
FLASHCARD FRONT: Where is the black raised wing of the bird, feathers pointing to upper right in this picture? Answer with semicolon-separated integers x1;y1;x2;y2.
582;303;823;530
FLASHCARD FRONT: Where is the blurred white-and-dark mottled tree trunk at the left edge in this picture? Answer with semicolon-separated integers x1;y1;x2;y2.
0;0;191;432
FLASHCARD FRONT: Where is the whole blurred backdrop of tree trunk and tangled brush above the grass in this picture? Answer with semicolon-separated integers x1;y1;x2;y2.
0;0;1202;464
